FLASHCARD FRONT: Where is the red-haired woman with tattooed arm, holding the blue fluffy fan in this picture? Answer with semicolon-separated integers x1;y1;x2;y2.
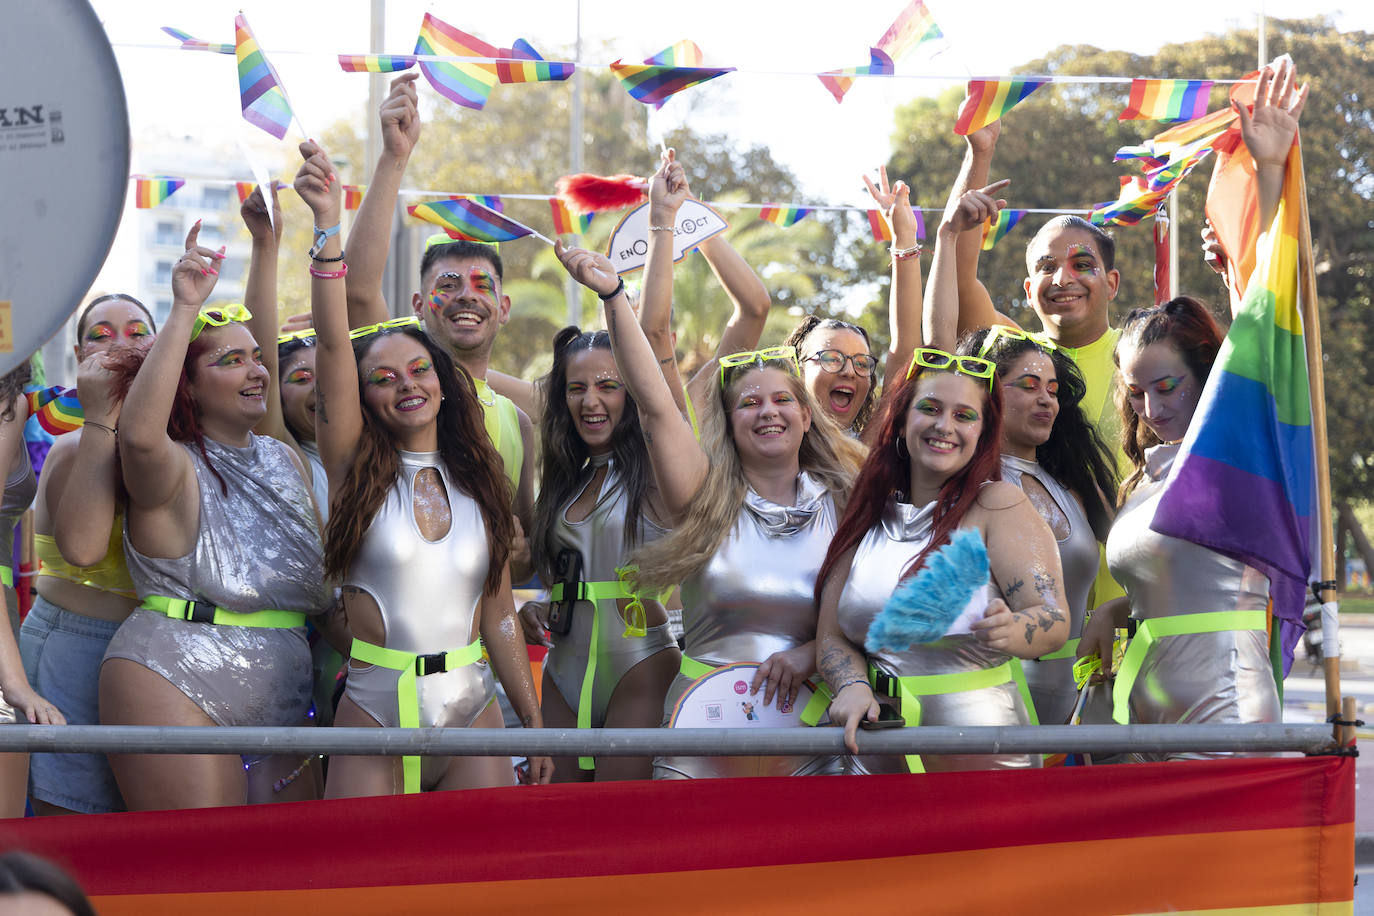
816;212;1069;773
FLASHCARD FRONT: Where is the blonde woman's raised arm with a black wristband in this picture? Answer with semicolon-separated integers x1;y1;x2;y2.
554;242;706;518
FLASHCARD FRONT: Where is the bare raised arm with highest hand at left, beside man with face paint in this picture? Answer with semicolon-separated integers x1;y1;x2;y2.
342;73;420;328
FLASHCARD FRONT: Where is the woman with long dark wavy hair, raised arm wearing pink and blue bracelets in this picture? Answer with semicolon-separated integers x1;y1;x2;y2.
295;143;552;798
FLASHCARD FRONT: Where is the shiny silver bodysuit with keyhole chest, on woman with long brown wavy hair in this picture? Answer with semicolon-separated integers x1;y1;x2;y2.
344;452;496;787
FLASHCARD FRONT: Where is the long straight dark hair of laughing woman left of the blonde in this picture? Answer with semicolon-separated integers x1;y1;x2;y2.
529;327;653;582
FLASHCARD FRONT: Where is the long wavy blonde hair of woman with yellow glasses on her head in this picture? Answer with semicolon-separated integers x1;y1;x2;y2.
631;354;864;588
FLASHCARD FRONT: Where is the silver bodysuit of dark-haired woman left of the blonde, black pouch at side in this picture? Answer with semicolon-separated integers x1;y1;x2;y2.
544;455;677;728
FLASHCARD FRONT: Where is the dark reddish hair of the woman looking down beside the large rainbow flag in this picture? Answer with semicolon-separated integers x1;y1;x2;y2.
1112;295;1224;507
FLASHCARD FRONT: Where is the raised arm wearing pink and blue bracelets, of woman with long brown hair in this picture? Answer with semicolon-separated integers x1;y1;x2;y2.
294;141;363;491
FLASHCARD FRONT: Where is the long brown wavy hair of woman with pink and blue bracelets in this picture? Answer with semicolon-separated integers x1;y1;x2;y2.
324;327;515;595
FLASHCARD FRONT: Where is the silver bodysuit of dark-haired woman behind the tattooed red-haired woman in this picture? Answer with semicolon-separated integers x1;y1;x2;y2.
1002;455;1098;725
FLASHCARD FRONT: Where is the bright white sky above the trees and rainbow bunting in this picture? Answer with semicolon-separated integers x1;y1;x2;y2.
92;0;1374;287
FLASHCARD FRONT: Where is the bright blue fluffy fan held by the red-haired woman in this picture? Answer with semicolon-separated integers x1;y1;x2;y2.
864;529;988;652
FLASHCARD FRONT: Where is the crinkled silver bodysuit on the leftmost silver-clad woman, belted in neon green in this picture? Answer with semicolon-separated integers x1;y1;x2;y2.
104;435;333;725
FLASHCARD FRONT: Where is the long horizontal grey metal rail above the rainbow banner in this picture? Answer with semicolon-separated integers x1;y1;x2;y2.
0;722;1336;757
